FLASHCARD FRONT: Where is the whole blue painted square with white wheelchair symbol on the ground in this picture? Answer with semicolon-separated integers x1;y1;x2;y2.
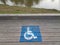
20;26;42;42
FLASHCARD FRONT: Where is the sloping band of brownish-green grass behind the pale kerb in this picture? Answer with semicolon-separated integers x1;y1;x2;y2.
0;5;60;14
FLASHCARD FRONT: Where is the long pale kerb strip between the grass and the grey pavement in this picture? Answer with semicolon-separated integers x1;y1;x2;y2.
0;14;60;16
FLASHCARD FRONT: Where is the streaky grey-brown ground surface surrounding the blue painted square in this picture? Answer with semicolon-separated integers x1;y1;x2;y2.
0;17;60;45
